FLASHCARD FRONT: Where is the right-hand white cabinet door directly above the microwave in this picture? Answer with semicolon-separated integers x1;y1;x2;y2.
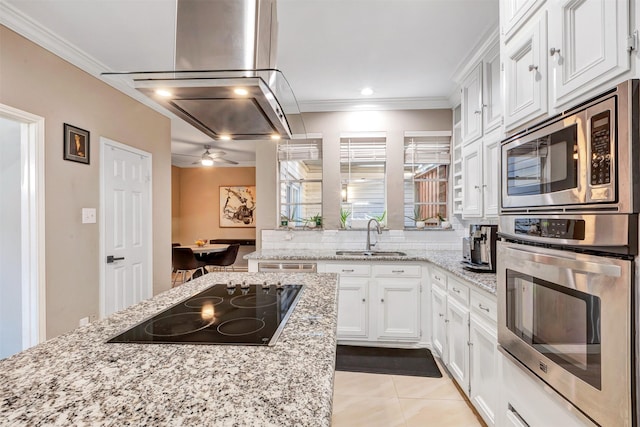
548;0;631;108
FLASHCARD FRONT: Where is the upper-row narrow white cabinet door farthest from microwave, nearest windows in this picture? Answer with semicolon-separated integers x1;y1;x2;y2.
461;63;482;144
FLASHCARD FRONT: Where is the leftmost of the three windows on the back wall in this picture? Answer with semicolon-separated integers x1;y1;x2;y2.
278;138;322;226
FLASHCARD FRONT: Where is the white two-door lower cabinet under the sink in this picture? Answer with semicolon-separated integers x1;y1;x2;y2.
324;263;422;342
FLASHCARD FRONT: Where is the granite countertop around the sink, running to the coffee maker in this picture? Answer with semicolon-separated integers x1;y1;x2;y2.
244;249;497;295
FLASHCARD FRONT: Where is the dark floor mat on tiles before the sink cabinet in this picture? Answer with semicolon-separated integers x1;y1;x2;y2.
336;345;442;378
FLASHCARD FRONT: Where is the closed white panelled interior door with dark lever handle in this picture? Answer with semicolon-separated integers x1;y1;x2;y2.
100;138;152;317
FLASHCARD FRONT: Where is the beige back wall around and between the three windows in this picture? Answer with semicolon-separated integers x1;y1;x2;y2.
256;109;452;234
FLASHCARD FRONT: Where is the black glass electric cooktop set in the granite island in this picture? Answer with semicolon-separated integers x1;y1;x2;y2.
107;282;303;345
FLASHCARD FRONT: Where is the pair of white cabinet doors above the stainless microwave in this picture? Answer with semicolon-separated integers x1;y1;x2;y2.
500;0;637;132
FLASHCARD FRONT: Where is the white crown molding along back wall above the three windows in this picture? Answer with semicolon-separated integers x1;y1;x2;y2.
298;97;451;113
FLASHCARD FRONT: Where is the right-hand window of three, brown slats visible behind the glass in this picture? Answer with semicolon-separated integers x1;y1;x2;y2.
404;132;451;228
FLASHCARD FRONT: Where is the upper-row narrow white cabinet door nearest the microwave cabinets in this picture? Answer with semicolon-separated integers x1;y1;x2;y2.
482;44;502;133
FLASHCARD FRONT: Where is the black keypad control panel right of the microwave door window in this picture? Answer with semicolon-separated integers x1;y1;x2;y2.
591;110;612;185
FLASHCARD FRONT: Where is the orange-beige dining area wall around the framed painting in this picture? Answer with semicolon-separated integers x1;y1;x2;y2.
172;167;258;245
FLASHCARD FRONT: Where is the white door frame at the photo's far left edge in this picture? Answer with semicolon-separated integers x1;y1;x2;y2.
0;104;47;349
